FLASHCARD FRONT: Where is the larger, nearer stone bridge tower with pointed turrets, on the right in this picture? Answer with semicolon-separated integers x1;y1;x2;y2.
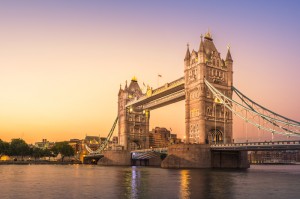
184;32;233;144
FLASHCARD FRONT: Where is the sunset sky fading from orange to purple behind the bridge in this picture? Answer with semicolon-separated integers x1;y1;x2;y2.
0;0;300;143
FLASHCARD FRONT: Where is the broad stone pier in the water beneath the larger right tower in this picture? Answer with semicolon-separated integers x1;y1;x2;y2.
161;144;249;169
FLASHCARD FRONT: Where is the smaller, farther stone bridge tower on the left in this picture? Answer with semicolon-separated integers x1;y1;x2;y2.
118;77;150;150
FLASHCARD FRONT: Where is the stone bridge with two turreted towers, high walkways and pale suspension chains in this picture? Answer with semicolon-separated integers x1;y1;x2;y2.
96;32;300;168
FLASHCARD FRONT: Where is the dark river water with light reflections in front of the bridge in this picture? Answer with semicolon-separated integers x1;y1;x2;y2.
0;165;300;199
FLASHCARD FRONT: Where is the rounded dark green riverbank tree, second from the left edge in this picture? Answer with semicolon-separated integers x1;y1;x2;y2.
9;138;30;160
